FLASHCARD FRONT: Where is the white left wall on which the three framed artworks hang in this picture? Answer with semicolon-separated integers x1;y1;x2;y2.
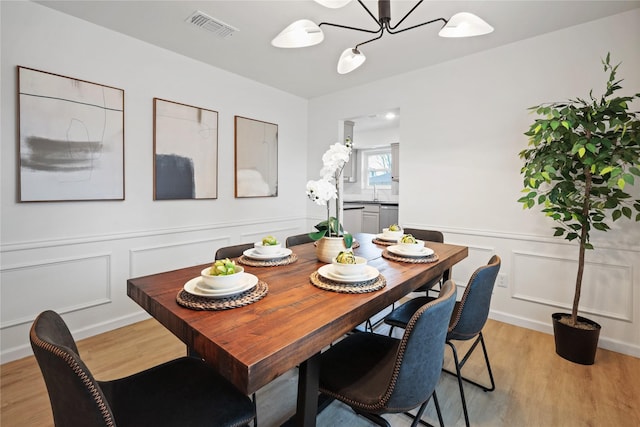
0;1;308;362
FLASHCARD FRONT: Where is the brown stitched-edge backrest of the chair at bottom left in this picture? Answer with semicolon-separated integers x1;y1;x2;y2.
29;311;116;427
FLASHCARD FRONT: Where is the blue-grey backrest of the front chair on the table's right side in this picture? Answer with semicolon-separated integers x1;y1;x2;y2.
382;280;456;410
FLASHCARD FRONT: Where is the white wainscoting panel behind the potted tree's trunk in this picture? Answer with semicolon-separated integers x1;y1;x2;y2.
511;251;633;322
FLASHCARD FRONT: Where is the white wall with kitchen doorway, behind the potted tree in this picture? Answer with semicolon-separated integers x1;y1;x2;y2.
308;9;640;356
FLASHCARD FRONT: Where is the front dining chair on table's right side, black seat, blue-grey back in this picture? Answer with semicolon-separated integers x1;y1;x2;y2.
320;281;456;427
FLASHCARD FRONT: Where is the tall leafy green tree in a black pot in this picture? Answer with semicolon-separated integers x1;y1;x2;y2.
518;54;640;364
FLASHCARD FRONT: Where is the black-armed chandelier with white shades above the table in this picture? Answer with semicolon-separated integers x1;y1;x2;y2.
271;0;493;74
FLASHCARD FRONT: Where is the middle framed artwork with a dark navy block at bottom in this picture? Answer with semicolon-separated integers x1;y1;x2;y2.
153;98;218;200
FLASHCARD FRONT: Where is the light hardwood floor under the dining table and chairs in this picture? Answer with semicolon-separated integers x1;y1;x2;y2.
0;320;640;427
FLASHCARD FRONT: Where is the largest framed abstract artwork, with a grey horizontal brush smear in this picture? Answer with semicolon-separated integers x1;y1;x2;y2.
18;66;124;202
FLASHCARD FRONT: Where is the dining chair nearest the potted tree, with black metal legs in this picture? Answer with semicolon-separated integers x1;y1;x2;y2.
384;255;501;427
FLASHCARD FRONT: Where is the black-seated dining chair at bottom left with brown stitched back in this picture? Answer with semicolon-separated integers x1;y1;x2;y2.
29;311;256;427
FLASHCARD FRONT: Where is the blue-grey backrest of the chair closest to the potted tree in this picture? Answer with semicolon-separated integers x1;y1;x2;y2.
447;255;501;340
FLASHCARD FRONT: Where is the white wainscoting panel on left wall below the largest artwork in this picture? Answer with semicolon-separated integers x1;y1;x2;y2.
0;253;111;329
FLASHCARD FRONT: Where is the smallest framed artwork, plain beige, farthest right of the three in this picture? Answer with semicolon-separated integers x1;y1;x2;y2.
235;116;278;197
